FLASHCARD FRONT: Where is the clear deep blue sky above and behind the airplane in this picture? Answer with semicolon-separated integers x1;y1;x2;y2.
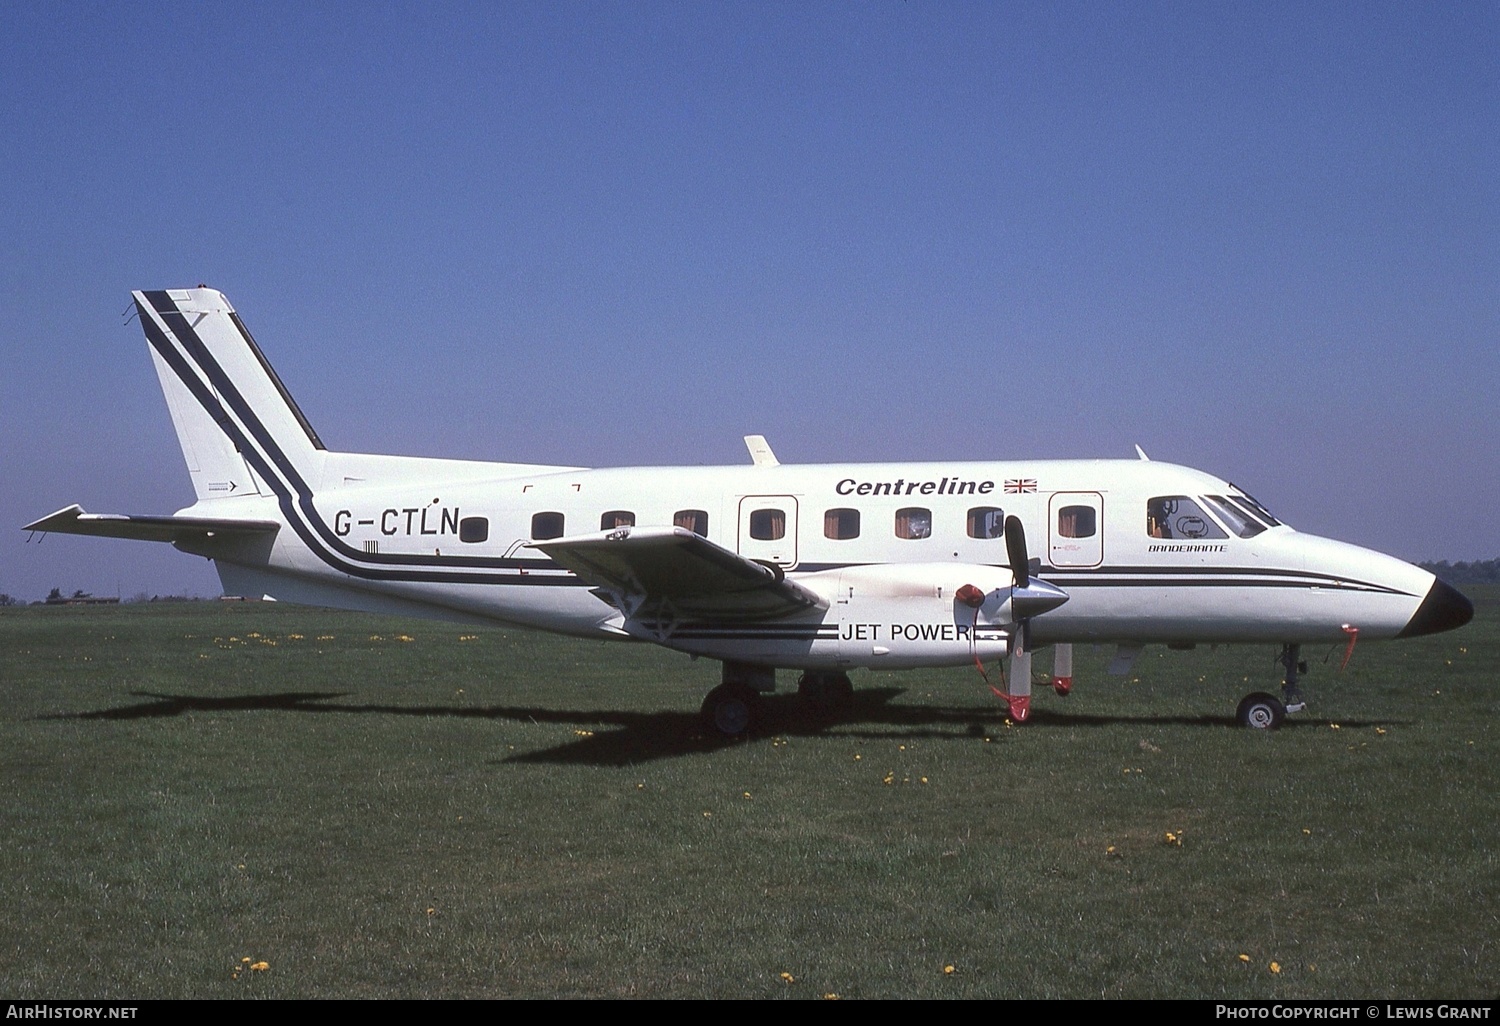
0;0;1500;599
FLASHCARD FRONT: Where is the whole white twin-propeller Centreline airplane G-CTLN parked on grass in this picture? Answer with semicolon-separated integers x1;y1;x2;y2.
24;287;1473;735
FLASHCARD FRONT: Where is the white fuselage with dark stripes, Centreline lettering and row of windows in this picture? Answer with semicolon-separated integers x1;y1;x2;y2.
183;453;1434;666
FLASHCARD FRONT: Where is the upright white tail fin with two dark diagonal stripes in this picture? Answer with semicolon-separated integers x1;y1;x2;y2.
134;288;326;501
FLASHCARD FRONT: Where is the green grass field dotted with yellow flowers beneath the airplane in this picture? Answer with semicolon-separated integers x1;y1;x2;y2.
0;588;1500;999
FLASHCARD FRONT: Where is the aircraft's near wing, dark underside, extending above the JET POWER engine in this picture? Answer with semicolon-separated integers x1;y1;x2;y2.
531;527;828;620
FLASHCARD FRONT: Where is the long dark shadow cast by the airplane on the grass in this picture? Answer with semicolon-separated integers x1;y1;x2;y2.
42;687;1392;765
